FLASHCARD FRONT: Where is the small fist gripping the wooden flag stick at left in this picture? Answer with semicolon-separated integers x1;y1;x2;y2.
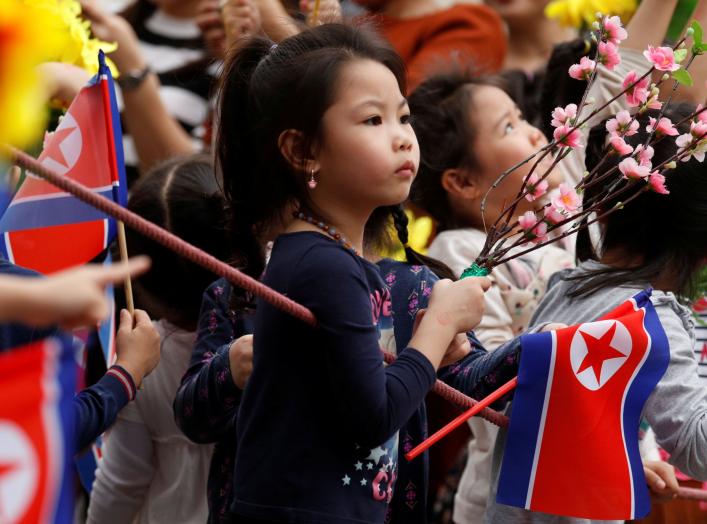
115;309;160;387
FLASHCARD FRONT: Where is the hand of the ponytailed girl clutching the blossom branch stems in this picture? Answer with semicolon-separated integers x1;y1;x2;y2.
426;277;491;336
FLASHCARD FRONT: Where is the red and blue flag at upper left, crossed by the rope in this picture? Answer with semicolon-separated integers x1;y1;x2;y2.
0;52;127;274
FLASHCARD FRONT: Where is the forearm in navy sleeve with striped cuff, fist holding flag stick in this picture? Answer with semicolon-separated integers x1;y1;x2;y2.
74;310;160;450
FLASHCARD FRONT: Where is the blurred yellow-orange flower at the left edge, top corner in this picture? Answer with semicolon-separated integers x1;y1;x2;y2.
0;0;66;147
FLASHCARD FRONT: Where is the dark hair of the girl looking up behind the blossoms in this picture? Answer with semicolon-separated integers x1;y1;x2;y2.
408;69;505;231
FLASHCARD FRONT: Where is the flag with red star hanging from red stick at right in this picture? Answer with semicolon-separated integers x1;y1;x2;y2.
496;291;670;520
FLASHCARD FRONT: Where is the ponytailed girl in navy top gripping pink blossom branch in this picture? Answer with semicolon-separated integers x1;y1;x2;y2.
217;25;496;523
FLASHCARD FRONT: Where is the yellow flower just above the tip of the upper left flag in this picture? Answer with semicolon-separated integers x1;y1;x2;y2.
23;0;118;76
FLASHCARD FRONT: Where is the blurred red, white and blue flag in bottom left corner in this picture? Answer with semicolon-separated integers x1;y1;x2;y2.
0;339;76;524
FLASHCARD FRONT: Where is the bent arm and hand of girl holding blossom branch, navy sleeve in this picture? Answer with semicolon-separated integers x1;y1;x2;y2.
296;246;488;445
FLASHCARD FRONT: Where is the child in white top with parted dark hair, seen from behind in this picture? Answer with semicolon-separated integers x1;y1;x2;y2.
88;156;227;523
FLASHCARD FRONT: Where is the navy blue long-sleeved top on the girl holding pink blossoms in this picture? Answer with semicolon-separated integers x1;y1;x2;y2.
232;232;435;524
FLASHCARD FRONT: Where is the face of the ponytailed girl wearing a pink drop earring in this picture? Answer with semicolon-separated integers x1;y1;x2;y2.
311;60;420;217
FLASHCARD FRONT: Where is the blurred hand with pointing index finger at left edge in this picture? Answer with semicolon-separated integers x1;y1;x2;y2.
8;257;150;329
